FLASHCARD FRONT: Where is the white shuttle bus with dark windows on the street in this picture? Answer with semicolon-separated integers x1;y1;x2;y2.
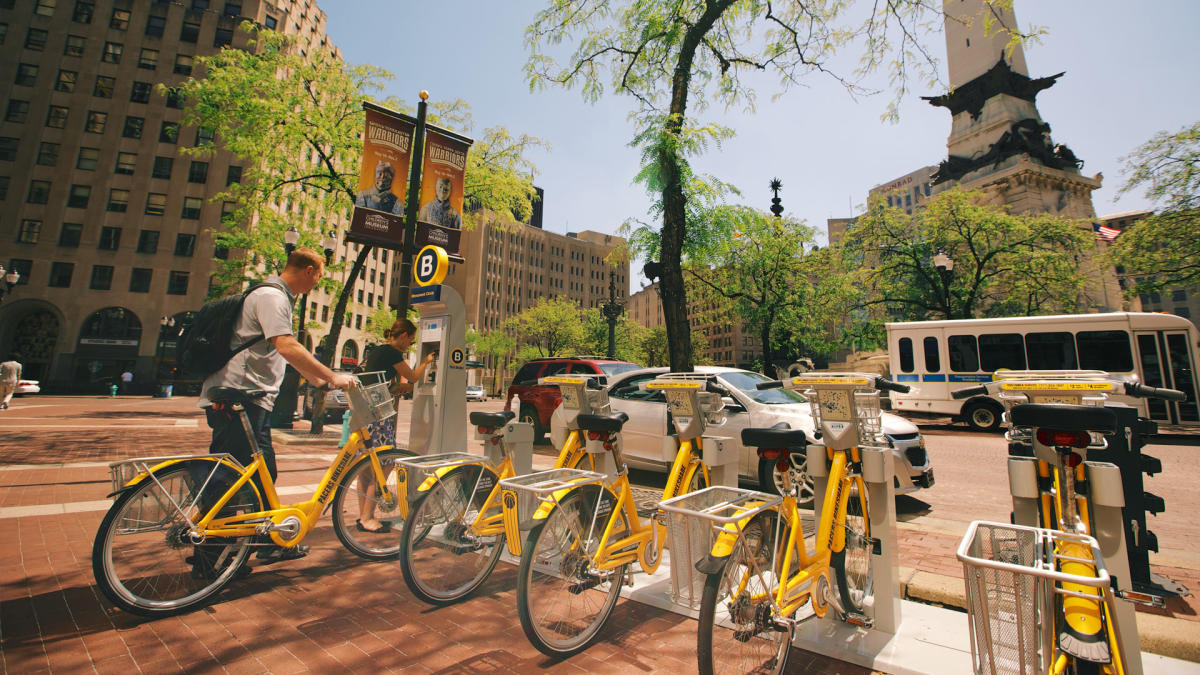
887;312;1200;430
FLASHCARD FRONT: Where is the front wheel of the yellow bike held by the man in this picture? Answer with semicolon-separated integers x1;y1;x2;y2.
331;449;413;561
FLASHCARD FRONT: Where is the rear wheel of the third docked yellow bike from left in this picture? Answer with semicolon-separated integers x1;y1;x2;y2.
696;512;791;675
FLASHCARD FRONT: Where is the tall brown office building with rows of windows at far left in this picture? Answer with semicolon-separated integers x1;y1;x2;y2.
0;0;388;390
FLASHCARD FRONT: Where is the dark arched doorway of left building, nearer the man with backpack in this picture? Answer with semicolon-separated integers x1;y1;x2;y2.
74;307;142;390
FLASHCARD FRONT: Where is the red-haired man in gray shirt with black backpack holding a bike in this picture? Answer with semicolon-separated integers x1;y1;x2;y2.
199;249;354;562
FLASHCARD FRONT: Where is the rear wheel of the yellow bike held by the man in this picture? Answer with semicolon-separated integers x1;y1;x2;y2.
91;464;255;617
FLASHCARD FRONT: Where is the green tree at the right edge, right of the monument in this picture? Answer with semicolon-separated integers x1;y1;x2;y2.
1109;123;1200;293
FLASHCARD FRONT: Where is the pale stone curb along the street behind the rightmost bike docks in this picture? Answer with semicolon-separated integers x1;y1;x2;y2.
900;567;1200;663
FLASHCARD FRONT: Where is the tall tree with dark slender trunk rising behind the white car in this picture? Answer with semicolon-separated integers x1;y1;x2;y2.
526;0;993;371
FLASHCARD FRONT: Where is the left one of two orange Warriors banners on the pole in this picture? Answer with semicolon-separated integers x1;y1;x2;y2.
346;104;416;250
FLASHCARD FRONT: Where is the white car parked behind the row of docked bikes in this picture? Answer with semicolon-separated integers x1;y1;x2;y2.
604;366;934;502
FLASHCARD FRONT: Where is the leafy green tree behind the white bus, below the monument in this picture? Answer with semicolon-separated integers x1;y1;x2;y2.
841;189;1092;321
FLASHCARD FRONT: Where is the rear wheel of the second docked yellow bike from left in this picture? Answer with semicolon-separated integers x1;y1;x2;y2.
517;485;629;658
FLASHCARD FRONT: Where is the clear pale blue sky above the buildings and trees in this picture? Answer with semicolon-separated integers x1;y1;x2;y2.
319;0;1200;257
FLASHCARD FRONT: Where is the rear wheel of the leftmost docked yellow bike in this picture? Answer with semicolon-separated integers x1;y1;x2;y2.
400;464;504;605
